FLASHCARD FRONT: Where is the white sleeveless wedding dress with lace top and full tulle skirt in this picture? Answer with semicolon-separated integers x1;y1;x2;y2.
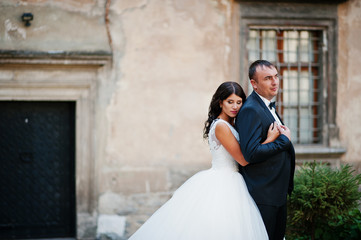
129;119;268;240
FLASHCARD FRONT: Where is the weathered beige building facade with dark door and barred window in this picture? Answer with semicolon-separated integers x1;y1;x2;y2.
0;0;361;239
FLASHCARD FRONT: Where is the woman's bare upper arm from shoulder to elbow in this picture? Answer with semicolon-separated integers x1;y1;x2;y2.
215;122;248;166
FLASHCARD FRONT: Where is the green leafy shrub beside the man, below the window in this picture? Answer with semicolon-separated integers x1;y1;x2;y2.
286;162;361;240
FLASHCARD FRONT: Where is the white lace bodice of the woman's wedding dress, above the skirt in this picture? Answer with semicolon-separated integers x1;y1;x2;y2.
208;119;239;171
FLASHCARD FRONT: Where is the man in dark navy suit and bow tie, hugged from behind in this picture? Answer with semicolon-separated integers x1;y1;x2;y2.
236;60;295;240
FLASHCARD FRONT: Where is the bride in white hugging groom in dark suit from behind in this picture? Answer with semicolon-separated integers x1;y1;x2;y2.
130;60;295;240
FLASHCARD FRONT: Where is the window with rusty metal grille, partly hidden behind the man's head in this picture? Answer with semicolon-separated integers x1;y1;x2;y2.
247;28;324;144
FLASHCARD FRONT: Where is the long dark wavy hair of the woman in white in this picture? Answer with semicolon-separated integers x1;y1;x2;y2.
203;82;246;139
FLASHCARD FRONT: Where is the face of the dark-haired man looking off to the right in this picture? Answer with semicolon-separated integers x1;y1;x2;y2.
251;66;280;101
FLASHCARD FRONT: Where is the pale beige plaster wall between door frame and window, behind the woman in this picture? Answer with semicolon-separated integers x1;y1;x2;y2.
97;0;232;234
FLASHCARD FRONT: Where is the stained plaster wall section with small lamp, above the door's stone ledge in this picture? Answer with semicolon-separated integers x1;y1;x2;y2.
0;0;110;52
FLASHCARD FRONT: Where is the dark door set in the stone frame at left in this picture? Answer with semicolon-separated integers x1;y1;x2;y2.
0;101;76;239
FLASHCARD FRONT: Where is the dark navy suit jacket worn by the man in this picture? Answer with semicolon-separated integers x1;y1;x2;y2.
236;92;295;206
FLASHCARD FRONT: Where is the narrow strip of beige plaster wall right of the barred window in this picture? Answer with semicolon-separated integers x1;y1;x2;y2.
337;0;361;170
